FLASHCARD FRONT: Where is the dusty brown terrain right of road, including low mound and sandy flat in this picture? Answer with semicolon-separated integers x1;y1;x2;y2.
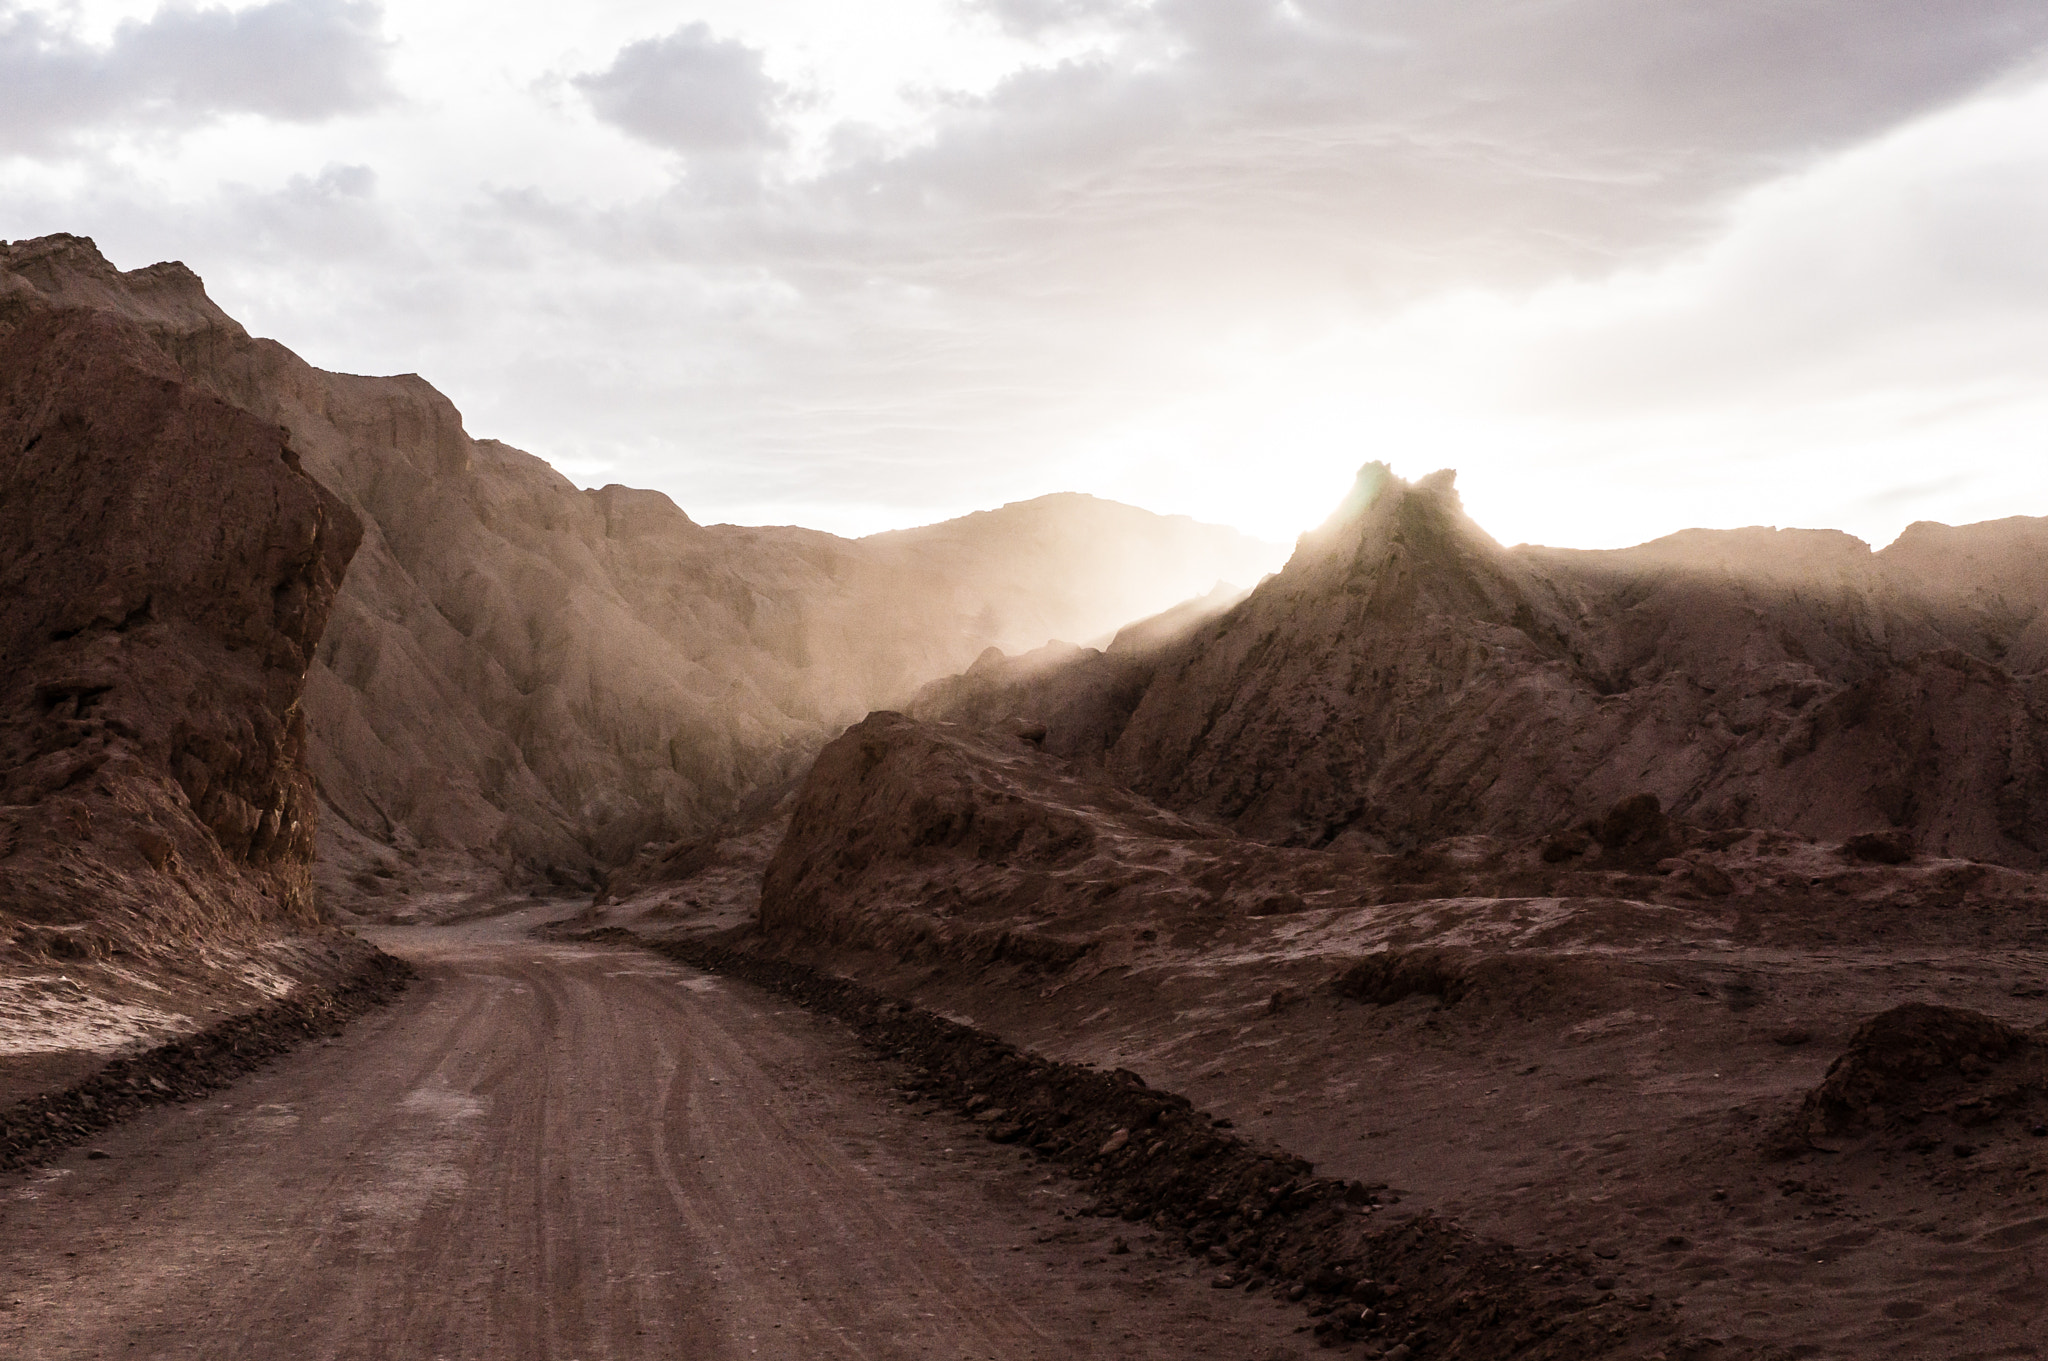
588;654;2048;1357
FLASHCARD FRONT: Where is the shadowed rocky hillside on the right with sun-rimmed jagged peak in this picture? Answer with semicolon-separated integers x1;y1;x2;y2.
913;465;2048;868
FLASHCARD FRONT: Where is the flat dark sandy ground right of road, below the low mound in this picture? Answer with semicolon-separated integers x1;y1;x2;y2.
786;903;2048;1361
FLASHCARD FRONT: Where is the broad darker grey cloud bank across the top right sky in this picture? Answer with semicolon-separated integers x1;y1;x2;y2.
794;0;2048;301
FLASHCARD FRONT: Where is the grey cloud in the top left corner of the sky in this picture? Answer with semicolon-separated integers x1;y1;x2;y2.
0;0;391;153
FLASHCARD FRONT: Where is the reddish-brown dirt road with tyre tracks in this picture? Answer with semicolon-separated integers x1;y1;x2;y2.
0;915;1305;1361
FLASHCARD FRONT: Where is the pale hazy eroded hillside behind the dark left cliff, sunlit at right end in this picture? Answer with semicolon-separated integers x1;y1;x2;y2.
0;235;1272;905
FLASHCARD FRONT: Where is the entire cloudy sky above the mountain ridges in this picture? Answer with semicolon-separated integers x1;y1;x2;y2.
0;0;2048;546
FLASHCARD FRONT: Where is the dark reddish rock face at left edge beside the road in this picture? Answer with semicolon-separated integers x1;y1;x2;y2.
0;307;360;958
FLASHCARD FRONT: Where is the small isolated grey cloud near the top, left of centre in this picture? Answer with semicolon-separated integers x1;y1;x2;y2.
573;23;788;153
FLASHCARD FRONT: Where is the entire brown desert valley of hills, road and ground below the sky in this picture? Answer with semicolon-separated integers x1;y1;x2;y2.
0;235;2048;1361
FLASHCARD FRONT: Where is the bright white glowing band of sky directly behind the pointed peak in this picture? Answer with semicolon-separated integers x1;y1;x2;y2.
1067;73;2048;546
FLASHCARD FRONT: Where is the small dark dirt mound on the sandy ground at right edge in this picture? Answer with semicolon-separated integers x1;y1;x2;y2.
1798;1003;2040;1134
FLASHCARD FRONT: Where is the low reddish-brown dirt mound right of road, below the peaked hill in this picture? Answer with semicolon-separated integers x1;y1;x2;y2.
757;712;2034;978
